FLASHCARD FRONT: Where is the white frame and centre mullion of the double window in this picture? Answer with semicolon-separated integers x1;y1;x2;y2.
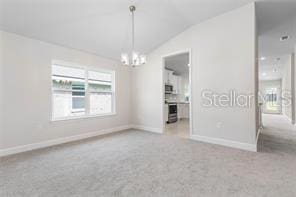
50;60;116;122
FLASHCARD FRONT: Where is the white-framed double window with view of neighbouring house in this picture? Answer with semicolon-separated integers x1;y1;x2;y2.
52;64;115;120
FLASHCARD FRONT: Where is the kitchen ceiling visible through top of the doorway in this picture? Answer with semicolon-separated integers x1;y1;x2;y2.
164;53;189;75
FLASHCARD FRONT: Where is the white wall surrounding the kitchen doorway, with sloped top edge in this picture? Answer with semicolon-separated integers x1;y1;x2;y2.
132;3;256;144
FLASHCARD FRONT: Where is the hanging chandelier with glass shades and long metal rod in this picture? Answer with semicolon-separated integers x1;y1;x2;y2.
121;5;146;67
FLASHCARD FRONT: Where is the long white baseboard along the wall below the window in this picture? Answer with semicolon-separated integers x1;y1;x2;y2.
0;125;132;157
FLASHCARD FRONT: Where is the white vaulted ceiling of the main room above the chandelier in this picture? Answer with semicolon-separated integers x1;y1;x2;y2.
0;0;254;59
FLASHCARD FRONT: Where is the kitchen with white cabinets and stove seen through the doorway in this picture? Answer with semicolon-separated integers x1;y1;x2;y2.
164;52;190;138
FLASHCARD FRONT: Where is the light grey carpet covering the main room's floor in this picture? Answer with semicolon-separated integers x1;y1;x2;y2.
0;130;296;197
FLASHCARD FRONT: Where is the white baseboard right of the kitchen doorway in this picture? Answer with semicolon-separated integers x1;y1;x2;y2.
190;135;257;152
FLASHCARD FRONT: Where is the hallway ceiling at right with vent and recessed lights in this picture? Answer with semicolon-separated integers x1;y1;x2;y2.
257;0;296;80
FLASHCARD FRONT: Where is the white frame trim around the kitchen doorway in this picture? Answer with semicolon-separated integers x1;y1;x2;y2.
161;48;193;138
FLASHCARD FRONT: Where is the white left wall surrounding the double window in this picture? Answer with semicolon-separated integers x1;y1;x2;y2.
0;32;131;149
